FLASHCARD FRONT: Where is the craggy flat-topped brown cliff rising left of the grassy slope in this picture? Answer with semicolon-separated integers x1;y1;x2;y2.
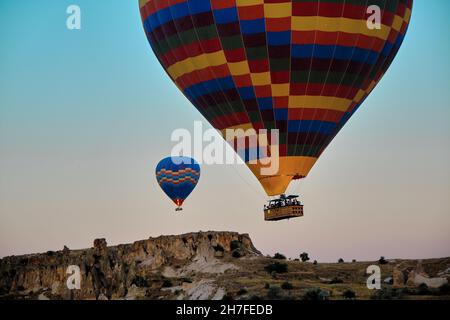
0;231;261;300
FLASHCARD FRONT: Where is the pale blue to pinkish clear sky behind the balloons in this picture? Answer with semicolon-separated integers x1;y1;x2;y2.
0;0;450;261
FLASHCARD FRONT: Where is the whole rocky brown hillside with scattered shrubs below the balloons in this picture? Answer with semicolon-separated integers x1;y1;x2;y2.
0;231;450;300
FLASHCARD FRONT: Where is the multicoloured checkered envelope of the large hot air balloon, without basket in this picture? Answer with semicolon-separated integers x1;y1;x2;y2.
140;0;412;195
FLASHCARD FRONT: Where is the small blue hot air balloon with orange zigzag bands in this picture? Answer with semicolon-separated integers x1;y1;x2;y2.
156;157;200;211
